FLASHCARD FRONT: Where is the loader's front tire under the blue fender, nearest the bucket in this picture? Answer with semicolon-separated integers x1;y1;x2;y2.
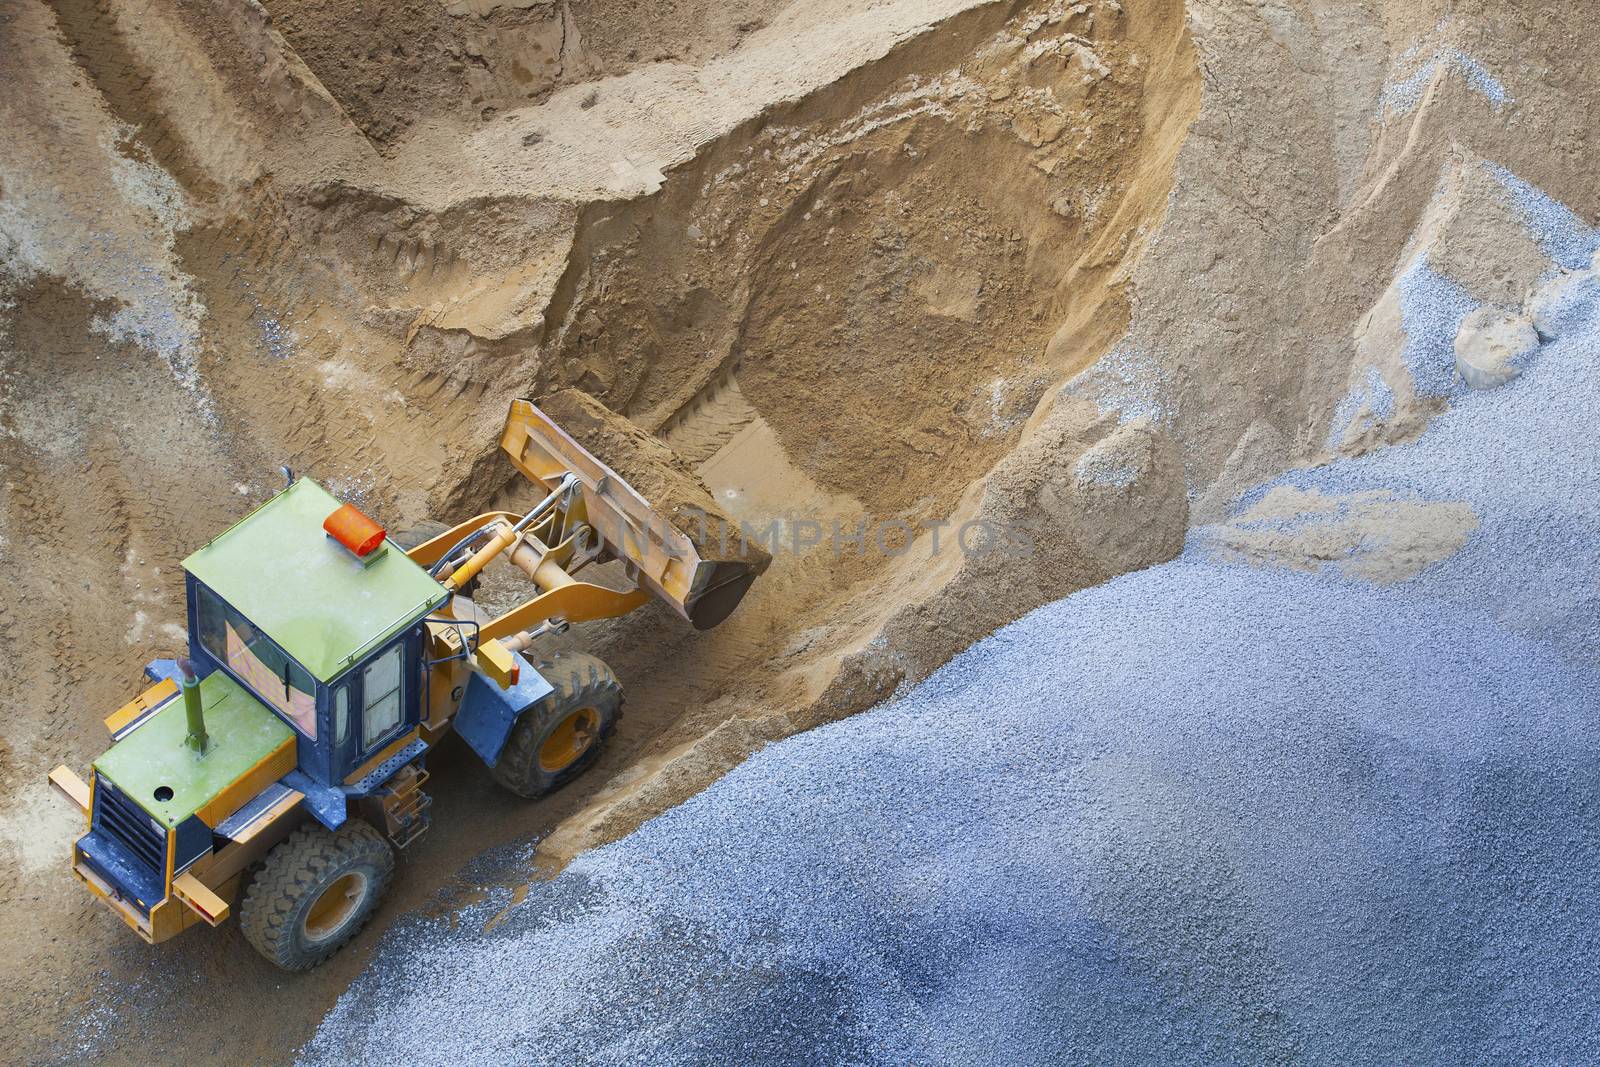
490;653;622;797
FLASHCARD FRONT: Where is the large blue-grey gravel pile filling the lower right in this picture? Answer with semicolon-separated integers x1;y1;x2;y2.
304;185;1600;1065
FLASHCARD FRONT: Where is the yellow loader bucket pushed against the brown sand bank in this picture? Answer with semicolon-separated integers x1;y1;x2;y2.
501;400;768;630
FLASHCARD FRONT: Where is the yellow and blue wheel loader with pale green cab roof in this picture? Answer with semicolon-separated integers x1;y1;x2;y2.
50;400;765;971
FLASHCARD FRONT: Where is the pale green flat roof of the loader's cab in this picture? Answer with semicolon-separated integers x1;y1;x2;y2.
184;478;450;681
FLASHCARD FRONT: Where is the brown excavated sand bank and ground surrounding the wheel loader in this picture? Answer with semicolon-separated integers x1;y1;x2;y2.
0;0;1600;1061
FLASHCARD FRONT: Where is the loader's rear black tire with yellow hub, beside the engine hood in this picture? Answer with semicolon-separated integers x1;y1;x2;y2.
238;821;395;971
